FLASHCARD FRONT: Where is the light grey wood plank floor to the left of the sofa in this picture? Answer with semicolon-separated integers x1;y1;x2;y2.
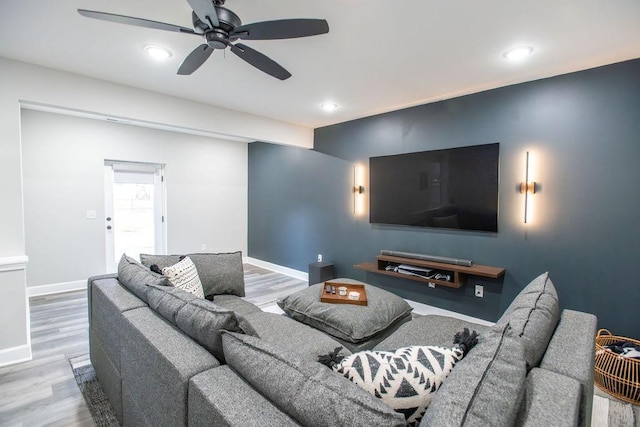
0;291;95;426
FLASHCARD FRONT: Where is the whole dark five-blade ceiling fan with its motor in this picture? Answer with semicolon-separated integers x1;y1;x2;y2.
78;0;329;80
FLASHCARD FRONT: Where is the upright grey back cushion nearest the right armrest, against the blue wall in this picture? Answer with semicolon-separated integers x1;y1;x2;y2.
497;273;560;369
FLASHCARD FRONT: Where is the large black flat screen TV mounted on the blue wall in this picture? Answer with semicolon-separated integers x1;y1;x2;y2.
369;143;500;233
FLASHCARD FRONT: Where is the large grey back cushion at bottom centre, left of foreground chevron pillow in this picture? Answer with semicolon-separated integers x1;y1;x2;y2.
222;332;405;427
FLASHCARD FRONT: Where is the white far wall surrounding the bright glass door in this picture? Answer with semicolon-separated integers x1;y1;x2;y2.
21;110;247;287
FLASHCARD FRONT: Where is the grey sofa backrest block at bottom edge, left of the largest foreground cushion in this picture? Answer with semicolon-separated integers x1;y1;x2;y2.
187;365;300;427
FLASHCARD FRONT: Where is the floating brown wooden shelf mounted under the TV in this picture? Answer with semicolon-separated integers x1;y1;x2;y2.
354;255;505;288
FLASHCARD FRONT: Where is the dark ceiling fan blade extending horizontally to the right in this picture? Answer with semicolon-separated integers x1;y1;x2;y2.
229;19;329;40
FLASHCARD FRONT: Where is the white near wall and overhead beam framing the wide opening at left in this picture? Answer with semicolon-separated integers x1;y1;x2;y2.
0;58;313;364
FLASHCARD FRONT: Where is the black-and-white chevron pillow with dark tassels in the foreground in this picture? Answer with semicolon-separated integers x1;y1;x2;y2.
332;346;464;425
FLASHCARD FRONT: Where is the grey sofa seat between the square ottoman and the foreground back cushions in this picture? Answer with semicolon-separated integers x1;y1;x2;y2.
238;310;351;362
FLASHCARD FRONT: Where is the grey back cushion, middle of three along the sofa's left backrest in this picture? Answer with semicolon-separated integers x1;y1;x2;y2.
149;286;245;362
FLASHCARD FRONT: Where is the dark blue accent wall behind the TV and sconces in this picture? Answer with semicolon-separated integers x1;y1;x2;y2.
249;60;640;337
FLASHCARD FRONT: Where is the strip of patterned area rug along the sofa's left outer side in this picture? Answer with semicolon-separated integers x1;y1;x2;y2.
69;354;120;427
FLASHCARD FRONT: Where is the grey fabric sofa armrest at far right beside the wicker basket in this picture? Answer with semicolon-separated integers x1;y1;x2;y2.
540;310;597;426
